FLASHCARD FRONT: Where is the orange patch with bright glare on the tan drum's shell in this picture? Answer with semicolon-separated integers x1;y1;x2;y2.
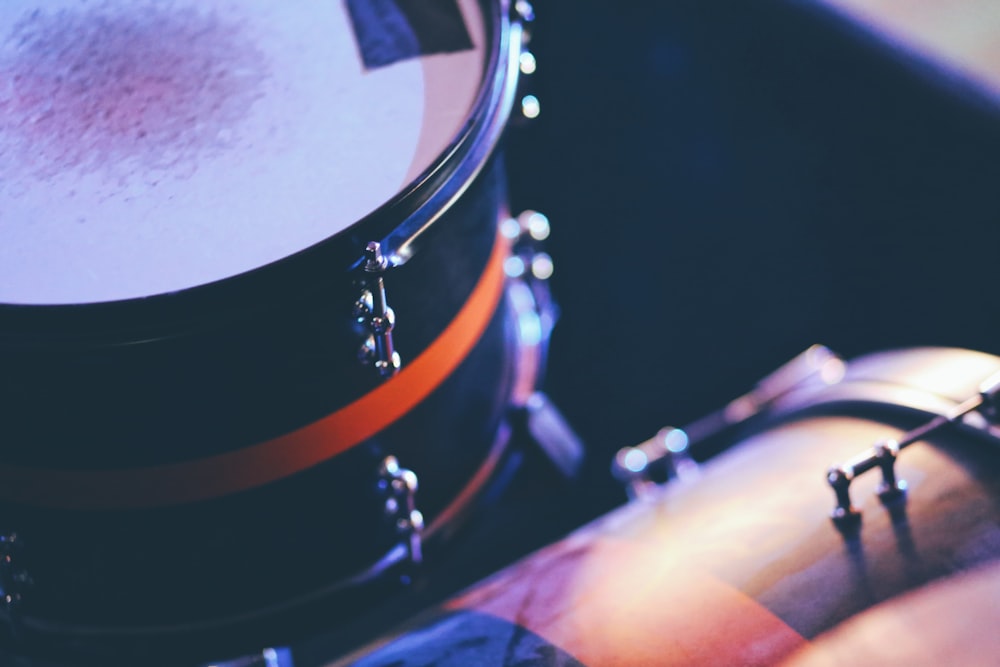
447;537;806;666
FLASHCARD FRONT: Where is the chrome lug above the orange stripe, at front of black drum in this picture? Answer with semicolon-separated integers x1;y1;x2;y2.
353;241;402;378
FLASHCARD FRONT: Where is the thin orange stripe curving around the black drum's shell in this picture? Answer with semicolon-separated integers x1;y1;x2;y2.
0;236;509;510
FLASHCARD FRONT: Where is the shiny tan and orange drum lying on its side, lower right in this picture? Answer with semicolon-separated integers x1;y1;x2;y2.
326;349;1000;667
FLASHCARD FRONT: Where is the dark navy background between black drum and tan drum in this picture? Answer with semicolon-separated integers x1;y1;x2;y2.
507;0;1000;510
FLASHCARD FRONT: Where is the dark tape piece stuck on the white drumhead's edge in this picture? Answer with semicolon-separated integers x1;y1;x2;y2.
347;0;472;69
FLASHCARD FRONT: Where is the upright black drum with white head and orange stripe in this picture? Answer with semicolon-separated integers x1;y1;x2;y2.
0;0;539;656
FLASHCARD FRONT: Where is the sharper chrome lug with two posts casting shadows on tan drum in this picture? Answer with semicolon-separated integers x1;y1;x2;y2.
826;373;1000;533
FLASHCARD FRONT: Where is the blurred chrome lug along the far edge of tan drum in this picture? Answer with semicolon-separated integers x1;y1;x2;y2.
611;345;845;500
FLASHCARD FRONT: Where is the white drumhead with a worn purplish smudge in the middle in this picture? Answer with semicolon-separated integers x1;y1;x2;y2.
0;0;486;304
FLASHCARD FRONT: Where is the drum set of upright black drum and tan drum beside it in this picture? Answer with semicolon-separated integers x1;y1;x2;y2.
0;0;1000;667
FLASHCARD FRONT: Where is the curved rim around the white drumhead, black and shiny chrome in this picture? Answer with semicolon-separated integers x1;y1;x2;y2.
0;0;521;347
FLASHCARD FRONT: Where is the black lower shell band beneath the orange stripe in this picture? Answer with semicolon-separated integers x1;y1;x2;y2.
4;276;518;636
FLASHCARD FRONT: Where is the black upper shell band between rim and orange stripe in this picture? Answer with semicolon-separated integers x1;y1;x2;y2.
0;145;504;469
